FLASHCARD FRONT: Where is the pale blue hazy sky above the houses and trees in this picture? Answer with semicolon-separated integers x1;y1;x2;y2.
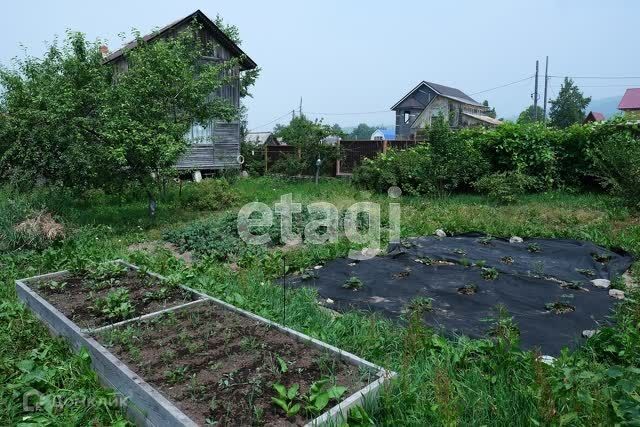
0;0;640;130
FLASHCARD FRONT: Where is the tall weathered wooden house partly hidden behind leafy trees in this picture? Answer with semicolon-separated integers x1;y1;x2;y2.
104;10;257;171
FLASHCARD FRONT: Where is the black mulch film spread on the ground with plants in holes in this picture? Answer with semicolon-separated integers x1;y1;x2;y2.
287;233;633;355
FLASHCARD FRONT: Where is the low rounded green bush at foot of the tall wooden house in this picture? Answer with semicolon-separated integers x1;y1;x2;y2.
180;178;239;211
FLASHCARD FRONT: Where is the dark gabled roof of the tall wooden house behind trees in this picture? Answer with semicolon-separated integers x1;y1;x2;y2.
105;9;258;70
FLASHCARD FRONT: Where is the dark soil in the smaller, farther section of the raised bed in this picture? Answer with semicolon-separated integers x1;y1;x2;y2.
36;270;198;328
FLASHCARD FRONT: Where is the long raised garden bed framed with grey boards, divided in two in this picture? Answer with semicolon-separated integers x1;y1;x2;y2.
16;261;395;425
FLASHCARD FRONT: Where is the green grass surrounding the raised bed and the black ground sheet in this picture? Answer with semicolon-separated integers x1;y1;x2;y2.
0;177;640;426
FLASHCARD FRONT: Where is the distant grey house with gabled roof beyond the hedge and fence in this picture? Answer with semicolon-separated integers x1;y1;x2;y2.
391;81;502;140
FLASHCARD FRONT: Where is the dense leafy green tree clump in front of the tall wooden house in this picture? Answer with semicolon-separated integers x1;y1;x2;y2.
0;24;237;204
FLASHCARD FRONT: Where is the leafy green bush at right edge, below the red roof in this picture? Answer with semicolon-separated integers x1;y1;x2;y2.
588;123;640;209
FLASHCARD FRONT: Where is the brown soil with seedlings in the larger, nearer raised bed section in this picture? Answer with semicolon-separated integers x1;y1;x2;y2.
97;302;374;426
